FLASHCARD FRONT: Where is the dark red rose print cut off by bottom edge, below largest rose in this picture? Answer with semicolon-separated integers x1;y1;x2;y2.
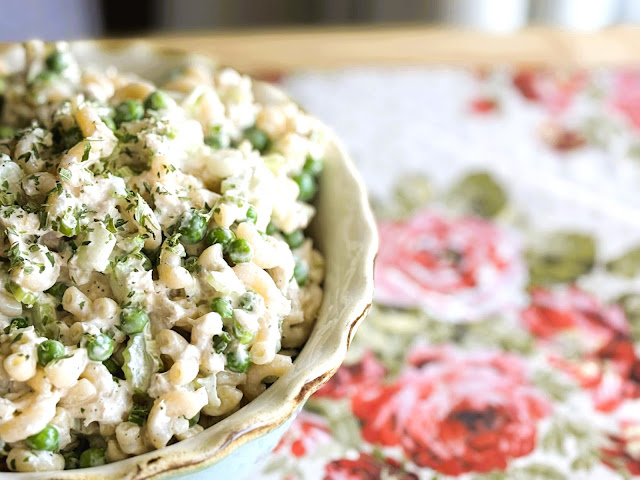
324;453;418;480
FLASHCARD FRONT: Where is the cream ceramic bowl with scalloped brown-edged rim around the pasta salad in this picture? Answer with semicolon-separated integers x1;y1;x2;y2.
0;42;377;480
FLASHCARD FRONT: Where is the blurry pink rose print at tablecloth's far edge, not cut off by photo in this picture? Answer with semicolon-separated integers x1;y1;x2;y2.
513;69;588;114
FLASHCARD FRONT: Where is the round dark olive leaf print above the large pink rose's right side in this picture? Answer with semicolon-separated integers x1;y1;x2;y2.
447;172;507;218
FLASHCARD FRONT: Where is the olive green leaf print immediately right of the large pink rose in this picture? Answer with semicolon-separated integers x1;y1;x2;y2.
525;231;596;285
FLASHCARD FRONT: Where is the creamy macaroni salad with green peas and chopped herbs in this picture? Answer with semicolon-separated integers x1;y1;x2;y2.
0;41;324;472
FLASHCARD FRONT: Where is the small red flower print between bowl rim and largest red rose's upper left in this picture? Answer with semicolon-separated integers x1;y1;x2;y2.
314;352;387;398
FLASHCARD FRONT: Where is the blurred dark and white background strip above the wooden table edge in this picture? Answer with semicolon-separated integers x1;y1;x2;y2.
0;0;640;42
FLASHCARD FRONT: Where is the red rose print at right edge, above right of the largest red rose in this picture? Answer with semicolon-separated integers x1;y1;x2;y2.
522;287;640;411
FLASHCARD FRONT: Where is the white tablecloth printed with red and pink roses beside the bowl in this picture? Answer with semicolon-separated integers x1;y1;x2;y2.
256;68;640;480
